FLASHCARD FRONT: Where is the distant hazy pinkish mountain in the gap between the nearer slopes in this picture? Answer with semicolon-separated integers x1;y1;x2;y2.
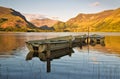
30;18;58;27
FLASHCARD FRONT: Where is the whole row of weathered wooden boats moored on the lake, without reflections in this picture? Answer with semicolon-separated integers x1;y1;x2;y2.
26;34;105;53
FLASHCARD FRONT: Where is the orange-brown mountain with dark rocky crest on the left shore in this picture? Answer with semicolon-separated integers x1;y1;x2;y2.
0;6;35;31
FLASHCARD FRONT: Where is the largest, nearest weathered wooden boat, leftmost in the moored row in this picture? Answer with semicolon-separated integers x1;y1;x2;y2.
26;35;73;52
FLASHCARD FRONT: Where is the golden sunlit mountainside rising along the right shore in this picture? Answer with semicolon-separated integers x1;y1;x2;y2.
54;8;120;32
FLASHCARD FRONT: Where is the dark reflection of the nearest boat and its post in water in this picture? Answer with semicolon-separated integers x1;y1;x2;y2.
26;48;73;72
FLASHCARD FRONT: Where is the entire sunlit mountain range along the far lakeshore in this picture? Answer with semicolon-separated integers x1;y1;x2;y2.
0;6;120;32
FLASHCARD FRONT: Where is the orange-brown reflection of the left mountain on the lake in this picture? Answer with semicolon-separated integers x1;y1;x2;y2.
0;34;25;55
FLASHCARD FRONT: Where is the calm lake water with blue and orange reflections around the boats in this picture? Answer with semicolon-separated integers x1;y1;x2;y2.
0;33;120;79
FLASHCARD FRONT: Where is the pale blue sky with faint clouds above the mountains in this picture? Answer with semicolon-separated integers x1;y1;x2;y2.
0;0;120;21
